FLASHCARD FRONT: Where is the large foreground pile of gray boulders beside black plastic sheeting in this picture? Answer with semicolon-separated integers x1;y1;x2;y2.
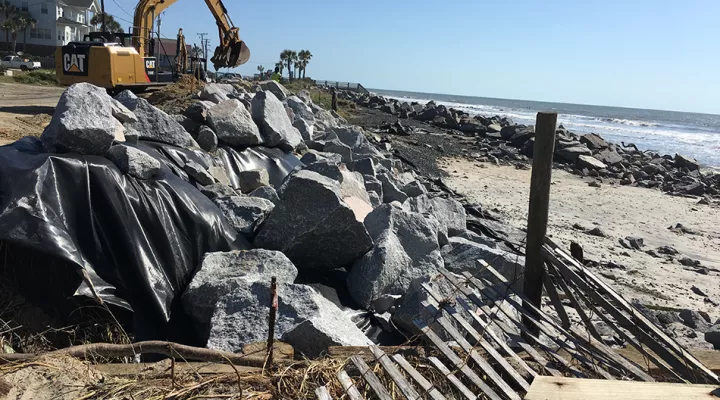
41;82;523;356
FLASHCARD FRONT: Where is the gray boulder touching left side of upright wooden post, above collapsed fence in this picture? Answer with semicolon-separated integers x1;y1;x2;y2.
441;237;525;282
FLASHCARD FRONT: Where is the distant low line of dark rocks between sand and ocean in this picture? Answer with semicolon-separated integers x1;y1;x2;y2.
344;92;720;202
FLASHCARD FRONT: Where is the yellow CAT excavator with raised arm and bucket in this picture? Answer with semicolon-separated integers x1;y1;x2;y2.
55;0;250;91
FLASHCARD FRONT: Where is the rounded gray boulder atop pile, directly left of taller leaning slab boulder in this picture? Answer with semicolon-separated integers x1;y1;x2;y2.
207;99;263;146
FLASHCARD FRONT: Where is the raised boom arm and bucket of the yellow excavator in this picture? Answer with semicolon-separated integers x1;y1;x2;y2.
133;0;250;70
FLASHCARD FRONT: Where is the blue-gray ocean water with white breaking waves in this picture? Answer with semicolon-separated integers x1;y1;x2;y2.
370;89;720;168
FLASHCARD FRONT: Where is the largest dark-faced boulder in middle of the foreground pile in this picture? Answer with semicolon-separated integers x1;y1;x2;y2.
255;170;372;270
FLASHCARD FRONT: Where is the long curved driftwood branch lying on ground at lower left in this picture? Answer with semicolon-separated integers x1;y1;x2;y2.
0;341;264;367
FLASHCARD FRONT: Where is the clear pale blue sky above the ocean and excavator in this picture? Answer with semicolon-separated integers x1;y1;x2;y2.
106;0;720;114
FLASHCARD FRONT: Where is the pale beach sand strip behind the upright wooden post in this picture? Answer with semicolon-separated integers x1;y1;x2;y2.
441;158;720;347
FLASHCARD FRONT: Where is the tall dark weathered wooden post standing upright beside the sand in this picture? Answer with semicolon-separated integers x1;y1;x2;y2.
523;112;557;332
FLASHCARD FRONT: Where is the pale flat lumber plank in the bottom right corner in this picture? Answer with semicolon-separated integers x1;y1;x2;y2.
525;376;720;400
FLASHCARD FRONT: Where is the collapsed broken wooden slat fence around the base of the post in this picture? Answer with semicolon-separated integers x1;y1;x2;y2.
316;244;720;400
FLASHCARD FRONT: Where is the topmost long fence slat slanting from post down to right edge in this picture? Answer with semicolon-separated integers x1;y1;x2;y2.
554;242;720;383
